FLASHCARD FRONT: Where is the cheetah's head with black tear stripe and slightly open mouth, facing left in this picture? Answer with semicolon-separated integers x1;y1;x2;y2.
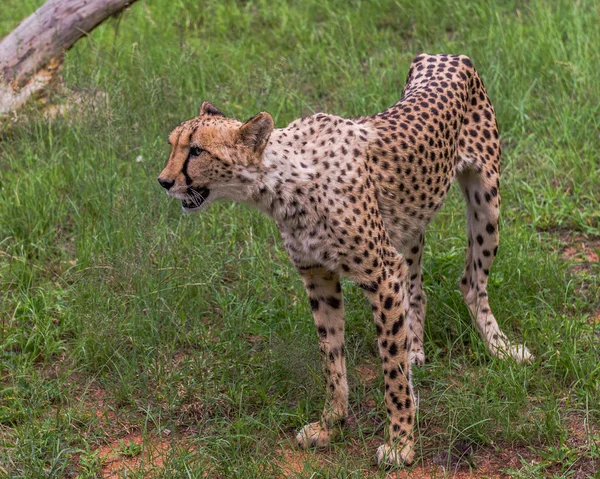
158;101;274;212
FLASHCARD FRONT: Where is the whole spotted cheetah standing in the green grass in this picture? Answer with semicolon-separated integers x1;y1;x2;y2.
158;54;533;465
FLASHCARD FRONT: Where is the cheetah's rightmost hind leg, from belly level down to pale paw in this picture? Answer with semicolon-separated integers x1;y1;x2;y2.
458;169;534;364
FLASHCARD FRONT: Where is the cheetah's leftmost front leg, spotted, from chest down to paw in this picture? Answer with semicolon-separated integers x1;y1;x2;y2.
296;268;348;448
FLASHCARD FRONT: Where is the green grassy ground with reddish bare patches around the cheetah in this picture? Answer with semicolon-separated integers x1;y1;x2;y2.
0;0;600;478
